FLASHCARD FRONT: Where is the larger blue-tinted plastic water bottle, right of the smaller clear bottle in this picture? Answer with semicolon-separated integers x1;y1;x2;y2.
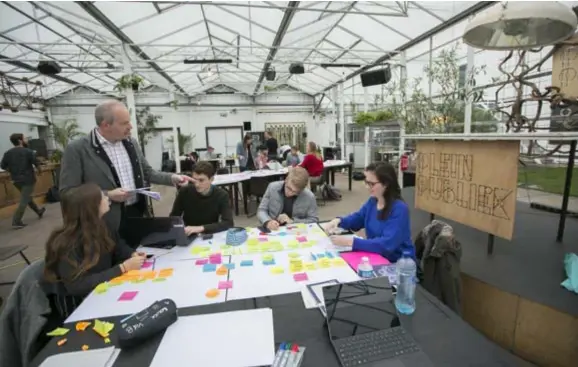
395;251;417;315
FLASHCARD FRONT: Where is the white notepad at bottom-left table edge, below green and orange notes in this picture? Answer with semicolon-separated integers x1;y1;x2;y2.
40;347;120;367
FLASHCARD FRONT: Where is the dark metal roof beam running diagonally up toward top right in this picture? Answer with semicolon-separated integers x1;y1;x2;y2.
318;1;497;94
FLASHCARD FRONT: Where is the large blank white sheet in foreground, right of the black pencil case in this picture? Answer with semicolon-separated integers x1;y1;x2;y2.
148;308;275;367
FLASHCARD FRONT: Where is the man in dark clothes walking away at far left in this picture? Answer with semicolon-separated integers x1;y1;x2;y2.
0;134;46;229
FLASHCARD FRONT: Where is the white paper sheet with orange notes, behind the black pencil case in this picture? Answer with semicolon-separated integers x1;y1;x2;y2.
66;256;223;322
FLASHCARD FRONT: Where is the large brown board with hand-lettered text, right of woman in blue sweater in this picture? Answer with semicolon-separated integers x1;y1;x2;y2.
416;141;517;242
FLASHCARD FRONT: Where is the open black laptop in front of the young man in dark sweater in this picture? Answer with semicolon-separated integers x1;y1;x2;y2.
127;217;194;249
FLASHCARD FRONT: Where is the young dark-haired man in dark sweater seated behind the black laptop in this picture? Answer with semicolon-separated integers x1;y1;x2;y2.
170;161;234;236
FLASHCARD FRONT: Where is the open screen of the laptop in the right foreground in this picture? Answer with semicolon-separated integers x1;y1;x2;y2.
323;277;399;340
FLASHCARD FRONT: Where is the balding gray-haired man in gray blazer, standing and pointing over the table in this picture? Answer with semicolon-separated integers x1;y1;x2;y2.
60;100;192;245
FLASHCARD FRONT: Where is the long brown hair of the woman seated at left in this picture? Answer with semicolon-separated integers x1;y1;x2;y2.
44;183;114;282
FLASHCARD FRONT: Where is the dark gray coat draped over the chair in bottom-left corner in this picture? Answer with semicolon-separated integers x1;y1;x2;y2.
0;260;50;367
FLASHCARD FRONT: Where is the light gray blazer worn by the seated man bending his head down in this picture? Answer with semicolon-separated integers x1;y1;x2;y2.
257;181;319;224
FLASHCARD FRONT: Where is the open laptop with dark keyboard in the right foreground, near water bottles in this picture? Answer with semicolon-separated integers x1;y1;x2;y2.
323;278;433;367
